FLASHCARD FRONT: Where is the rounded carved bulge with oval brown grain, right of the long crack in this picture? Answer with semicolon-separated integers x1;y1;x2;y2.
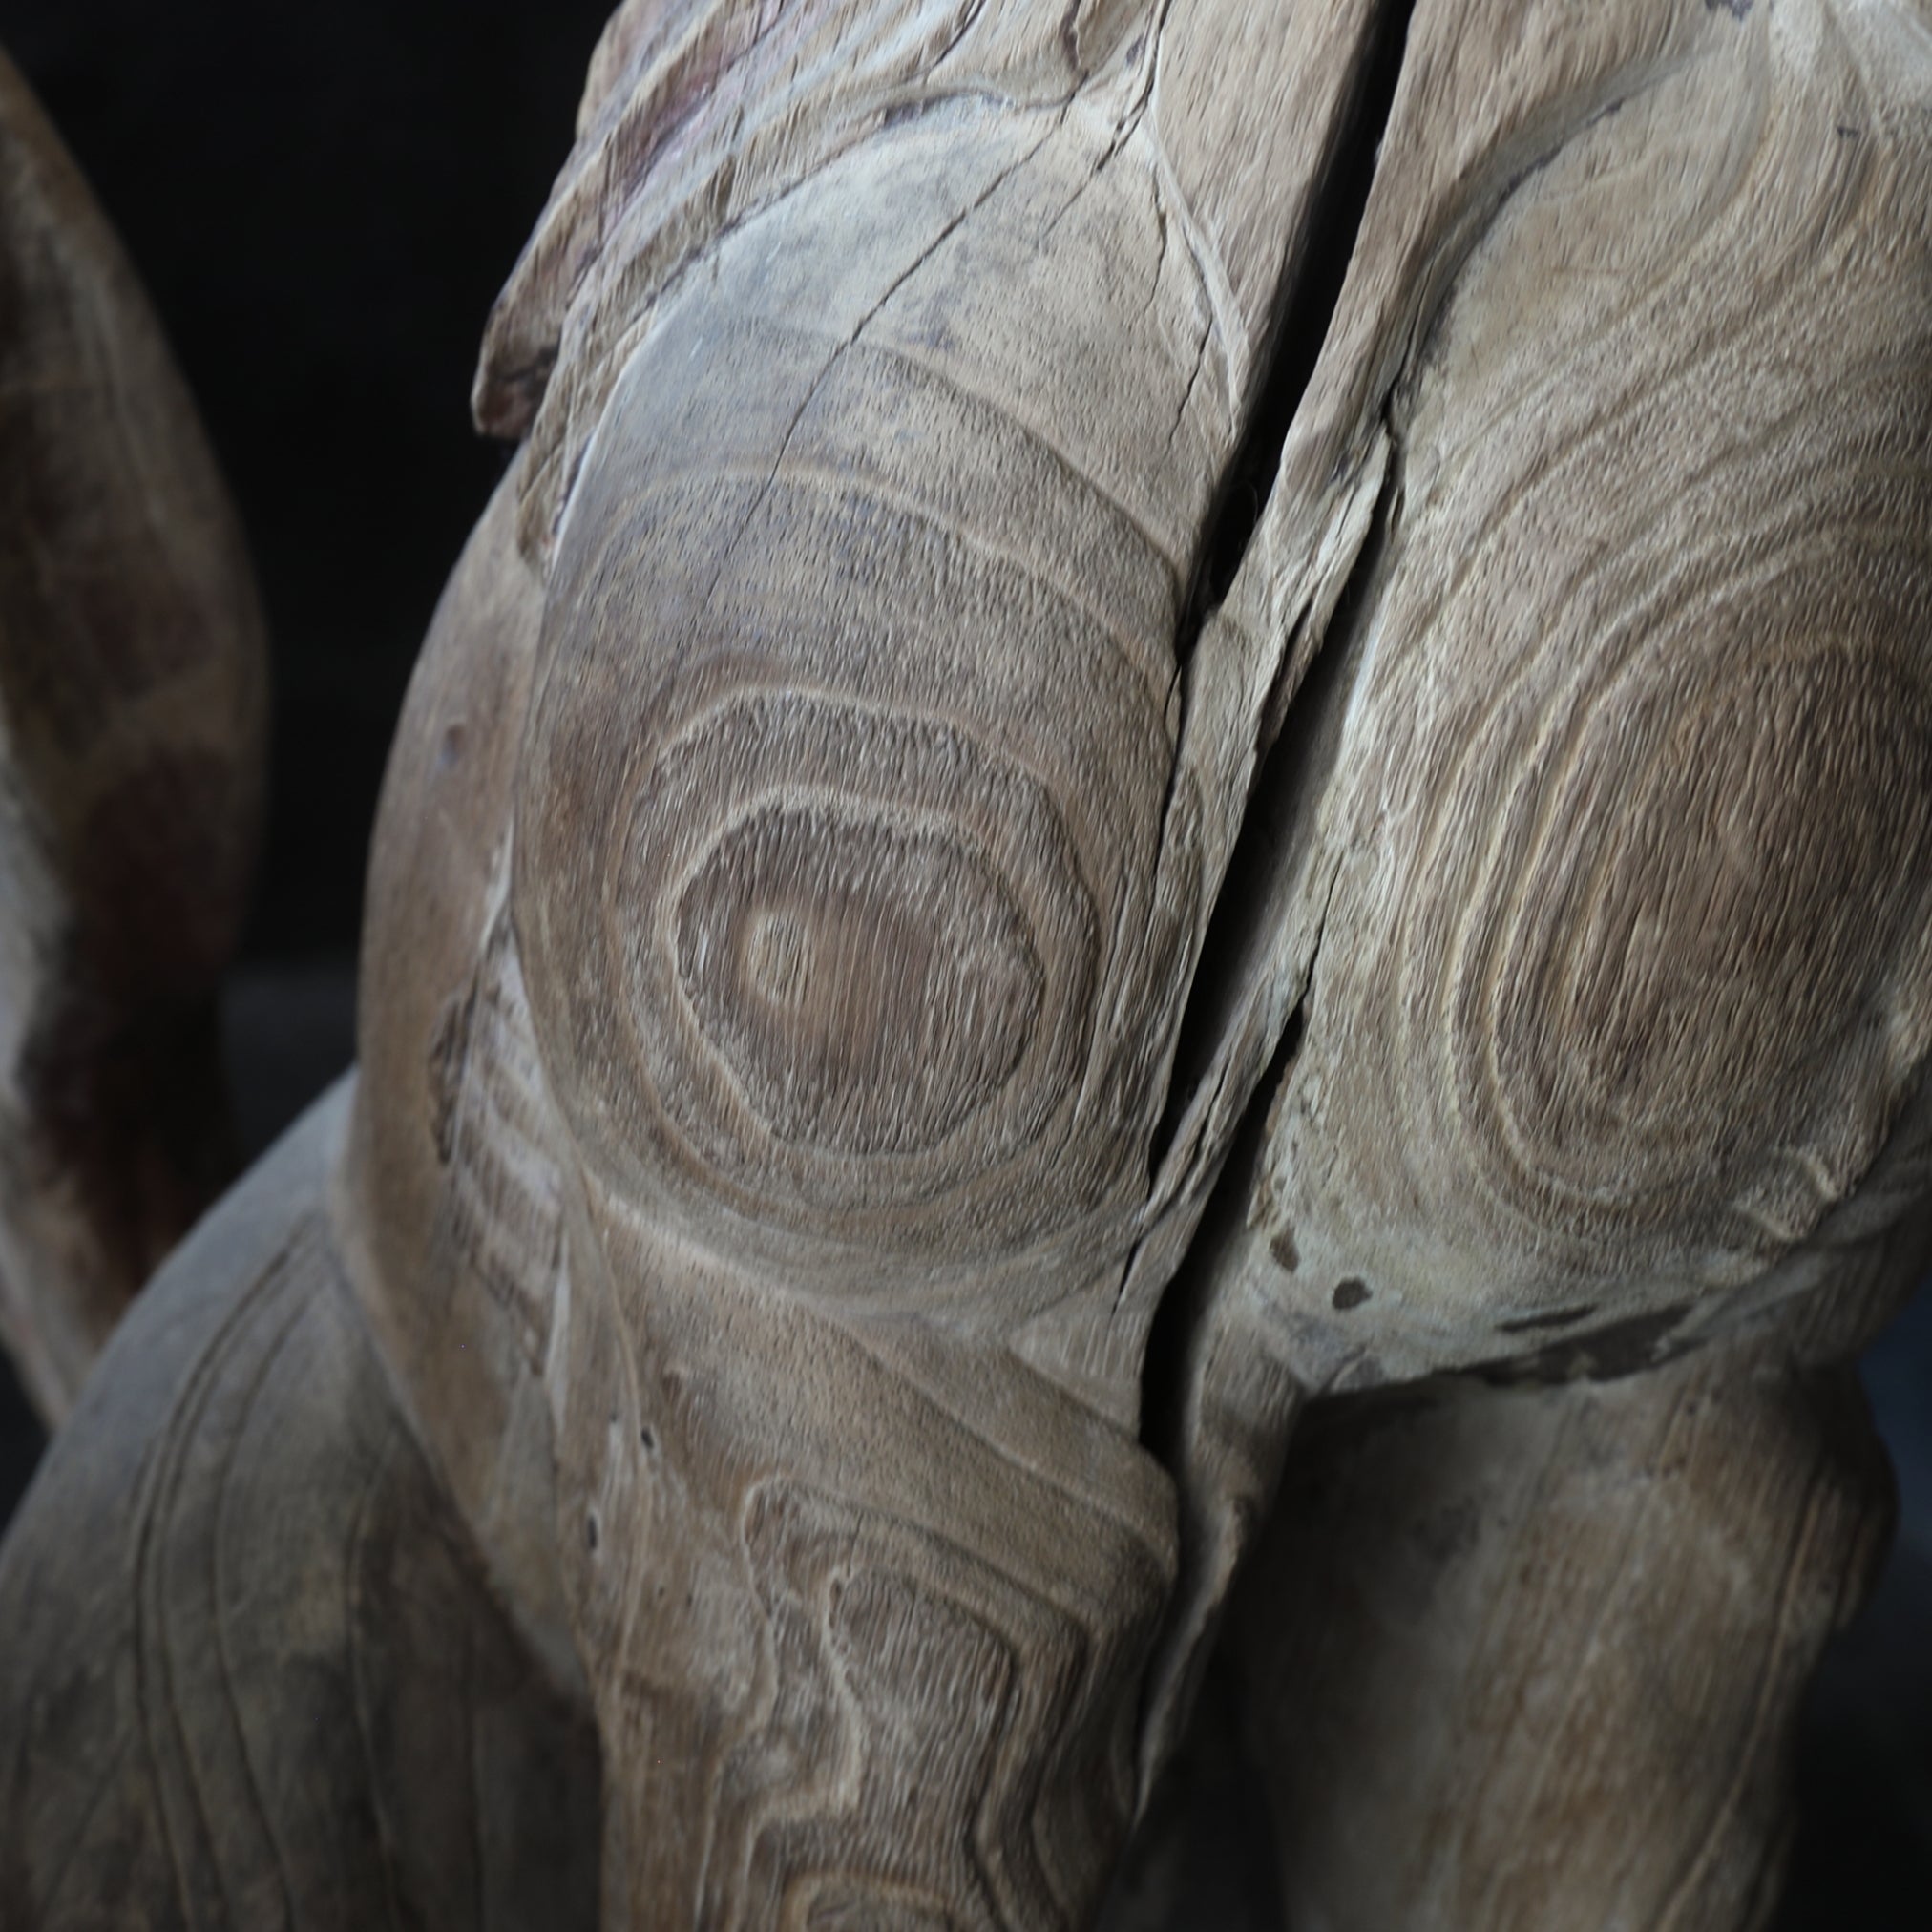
1228;3;1932;1370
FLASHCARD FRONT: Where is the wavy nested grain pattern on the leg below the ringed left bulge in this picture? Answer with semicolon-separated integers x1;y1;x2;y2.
707;1480;1088;1928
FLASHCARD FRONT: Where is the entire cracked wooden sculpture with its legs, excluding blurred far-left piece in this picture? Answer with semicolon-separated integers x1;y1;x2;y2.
0;0;1932;1932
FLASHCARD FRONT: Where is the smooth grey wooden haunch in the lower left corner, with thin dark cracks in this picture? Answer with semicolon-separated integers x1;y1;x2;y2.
0;1090;597;1932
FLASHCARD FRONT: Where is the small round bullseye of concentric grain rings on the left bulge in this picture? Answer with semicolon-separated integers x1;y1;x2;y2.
611;690;1100;1211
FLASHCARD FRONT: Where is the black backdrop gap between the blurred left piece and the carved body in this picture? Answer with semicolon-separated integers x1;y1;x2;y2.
0;0;615;960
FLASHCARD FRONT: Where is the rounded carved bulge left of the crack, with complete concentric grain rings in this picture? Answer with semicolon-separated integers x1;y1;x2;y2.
515;122;1228;1292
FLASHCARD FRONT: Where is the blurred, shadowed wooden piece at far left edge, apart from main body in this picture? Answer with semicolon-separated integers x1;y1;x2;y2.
0;56;266;1424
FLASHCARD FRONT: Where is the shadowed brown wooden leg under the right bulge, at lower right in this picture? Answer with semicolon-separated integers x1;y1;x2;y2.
1230;1353;1891;1932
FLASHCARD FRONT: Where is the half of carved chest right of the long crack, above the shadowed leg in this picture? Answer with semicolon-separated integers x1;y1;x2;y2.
1144;4;1932;1754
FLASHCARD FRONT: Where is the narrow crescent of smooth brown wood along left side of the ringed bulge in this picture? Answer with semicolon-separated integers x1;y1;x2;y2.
332;462;598;1679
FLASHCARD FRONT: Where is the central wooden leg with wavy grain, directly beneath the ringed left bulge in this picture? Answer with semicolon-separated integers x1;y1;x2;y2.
560;1246;1171;1932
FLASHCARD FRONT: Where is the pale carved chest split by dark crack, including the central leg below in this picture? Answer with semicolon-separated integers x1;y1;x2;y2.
355;0;1932;1924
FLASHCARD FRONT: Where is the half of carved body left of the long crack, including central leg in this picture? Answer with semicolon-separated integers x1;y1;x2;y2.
346;8;1421;1924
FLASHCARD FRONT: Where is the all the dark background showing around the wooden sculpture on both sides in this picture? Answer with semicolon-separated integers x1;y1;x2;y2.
0;0;1932;1932
